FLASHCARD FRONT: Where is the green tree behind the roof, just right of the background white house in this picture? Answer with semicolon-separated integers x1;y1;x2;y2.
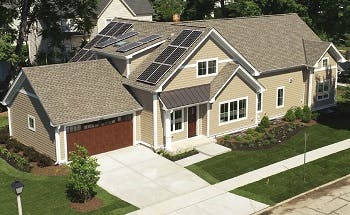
154;0;185;21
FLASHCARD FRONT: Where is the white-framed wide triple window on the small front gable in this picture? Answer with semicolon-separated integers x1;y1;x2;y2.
220;98;247;123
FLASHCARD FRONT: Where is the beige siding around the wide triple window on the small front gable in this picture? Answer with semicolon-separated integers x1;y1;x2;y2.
209;75;256;136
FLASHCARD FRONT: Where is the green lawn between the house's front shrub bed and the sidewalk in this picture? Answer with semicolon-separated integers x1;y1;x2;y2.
187;116;350;184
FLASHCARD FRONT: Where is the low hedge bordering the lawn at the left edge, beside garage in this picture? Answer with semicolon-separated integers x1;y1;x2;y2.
0;147;32;172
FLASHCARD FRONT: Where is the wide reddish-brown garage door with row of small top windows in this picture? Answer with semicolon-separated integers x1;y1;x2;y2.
67;115;133;155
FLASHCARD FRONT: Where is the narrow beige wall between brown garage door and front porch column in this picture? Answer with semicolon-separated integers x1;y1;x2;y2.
131;88;153;145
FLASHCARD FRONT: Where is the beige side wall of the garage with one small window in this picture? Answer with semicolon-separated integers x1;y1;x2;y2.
11;93;56;160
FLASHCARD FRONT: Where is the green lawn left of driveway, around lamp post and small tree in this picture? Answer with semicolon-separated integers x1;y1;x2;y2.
0;159;137;215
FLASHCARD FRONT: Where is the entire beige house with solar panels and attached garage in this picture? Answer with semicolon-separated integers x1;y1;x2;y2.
2;14;345;163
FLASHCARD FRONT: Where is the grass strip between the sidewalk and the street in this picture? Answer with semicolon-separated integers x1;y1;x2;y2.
231;149;350;205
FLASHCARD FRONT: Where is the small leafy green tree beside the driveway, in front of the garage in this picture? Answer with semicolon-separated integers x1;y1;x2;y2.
67;145;100;203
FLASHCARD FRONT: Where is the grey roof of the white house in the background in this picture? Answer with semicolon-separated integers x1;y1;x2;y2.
120;0;153;16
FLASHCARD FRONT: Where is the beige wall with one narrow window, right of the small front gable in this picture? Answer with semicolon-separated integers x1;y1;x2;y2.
258;70;308;119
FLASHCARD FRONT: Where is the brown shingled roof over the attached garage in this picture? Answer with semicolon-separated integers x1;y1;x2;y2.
5;60;142;126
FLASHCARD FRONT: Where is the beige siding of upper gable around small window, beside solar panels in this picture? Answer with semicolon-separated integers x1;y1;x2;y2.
165;39;235;91
